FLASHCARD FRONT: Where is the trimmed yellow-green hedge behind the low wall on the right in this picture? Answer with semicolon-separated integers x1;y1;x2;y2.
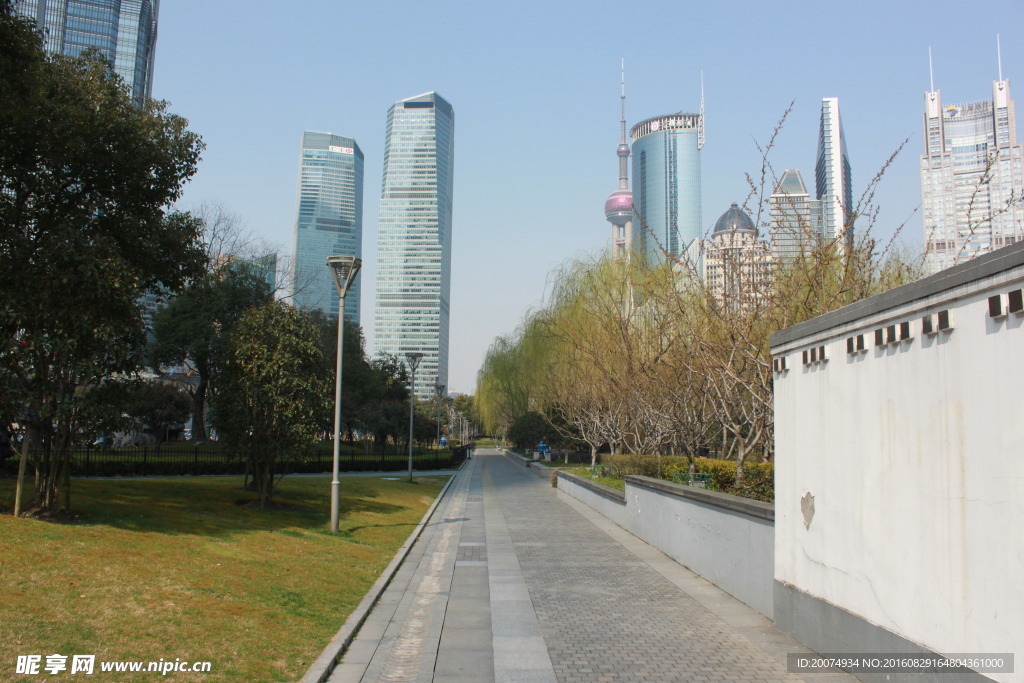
599;454;775;503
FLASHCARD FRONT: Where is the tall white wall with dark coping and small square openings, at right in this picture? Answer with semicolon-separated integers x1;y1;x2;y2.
772;255;1024;680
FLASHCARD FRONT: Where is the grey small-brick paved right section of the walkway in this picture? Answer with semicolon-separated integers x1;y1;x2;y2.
485;458;827;682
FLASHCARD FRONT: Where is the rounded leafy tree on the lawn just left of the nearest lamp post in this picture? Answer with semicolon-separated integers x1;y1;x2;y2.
212;301;332;508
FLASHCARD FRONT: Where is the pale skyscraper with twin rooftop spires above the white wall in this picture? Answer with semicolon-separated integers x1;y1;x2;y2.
921;63;1024;273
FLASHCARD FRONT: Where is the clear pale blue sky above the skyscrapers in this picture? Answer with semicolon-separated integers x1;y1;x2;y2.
154;0;1024;392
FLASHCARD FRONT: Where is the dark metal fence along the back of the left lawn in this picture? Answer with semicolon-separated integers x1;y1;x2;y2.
0;443;466;476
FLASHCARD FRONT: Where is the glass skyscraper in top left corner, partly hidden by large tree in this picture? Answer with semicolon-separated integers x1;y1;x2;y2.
14;0;160;101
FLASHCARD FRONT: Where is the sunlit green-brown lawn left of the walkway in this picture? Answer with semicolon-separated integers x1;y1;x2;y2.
0;477;446;681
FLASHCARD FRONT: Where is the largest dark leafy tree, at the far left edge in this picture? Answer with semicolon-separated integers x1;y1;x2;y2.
0;0;203;510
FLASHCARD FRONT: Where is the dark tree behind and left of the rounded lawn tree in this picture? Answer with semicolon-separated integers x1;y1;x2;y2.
148;266;271;441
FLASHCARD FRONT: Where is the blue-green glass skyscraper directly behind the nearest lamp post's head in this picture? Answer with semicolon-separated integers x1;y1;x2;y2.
292;130;362;323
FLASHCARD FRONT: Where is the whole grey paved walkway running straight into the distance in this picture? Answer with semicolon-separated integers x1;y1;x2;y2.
330;450;852;683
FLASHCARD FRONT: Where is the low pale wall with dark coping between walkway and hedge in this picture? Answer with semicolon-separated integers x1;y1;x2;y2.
558;471;775;618
